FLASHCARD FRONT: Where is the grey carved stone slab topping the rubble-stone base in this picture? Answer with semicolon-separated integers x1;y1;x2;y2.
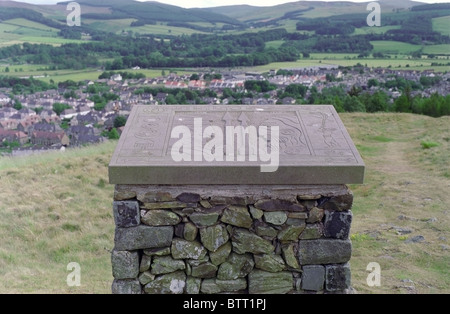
109;105;365;185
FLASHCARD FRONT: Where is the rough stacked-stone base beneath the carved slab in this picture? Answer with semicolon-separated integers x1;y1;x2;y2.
111;185;353;294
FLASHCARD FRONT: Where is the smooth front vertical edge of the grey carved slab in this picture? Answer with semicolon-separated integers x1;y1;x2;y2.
109;165;365;185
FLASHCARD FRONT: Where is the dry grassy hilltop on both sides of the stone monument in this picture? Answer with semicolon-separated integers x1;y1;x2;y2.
0;114;450;293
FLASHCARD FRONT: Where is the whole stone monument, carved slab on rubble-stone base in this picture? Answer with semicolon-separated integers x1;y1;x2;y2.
109;105;365;294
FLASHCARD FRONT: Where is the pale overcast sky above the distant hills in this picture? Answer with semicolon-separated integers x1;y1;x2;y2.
10;0;450;8
